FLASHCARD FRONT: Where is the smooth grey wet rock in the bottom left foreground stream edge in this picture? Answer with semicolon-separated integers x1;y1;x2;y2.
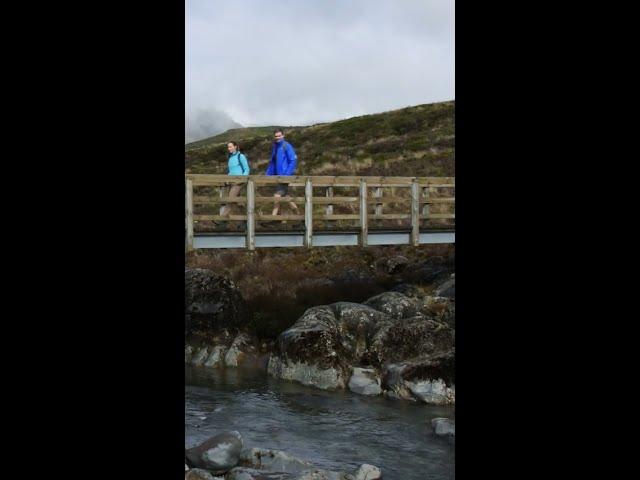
185;431;242;475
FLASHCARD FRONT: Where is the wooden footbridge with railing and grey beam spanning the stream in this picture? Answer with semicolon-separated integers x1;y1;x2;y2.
185;174;455;250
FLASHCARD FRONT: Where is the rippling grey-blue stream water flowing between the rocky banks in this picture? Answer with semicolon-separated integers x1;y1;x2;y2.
185;367;455;480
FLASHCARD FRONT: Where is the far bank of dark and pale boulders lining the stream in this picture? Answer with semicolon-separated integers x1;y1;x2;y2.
185;258;455;405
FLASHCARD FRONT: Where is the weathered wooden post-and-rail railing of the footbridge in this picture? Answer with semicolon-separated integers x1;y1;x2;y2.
185;174;455;250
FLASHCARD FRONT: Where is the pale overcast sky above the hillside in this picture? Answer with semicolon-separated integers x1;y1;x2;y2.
185;0;455;139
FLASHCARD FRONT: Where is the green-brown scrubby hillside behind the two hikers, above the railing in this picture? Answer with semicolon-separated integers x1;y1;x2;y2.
185;101;455;176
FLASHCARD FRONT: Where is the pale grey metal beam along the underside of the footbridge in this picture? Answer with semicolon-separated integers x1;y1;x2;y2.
193;230;456;248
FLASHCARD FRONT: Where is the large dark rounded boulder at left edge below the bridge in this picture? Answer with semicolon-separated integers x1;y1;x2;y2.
185;268;248;338
